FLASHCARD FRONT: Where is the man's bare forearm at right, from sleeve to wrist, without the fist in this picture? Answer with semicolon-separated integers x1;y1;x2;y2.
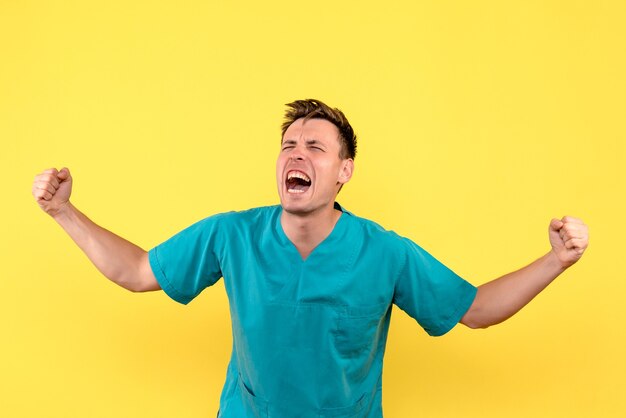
461;251;565;328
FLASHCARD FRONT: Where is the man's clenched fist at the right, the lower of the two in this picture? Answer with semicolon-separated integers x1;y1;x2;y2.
549;216;589;268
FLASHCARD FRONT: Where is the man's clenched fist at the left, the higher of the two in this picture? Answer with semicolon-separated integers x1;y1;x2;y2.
33;168;72;216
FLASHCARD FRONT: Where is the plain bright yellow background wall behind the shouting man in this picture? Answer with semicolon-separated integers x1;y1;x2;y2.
0;0;626;418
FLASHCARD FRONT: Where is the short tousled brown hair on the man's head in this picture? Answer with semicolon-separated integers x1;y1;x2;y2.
282;99;356;159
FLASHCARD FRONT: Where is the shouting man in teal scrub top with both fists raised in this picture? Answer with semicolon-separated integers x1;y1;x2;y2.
33;100;588;418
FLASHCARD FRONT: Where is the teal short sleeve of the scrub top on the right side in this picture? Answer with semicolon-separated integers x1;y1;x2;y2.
394;238;477;336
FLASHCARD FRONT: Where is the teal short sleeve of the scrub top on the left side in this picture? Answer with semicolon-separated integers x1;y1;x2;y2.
148;215;223;304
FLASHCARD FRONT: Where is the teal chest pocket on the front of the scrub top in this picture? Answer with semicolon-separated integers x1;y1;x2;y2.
334;303;390;358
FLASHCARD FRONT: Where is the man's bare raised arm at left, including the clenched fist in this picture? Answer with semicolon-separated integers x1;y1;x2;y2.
32;168;160;292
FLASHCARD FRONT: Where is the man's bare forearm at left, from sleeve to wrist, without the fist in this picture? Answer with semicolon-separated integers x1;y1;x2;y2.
54;202;147;291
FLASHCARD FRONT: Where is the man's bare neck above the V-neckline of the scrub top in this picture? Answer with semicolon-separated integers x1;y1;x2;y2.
280;205;341;260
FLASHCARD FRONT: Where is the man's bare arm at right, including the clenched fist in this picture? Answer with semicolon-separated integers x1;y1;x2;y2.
460;216;589;328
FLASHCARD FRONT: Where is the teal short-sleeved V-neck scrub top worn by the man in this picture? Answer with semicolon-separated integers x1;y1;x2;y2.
149;204;476;418
